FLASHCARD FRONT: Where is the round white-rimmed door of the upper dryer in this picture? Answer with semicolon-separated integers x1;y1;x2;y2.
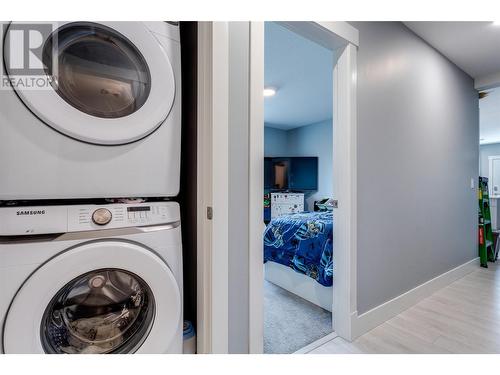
4;22;175;145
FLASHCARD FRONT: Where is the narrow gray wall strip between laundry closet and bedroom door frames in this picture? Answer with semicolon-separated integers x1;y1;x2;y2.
228;22;250;353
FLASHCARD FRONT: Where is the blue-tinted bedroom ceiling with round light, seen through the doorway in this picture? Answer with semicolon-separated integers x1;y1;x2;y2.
264;22;333;129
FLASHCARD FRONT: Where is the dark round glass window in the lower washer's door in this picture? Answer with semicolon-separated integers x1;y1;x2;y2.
40;268;155;354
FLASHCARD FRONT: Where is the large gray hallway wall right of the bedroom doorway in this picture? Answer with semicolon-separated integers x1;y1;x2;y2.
353;22;479;313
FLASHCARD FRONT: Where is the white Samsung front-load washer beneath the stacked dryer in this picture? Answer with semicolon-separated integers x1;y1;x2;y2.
0;202;183;353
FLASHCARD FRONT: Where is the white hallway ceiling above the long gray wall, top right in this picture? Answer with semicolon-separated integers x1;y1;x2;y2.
404;22;500;79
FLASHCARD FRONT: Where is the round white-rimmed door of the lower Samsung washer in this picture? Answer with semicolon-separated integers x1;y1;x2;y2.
3;241;181;354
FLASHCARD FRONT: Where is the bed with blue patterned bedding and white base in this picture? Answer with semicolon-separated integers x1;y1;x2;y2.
264;211;333;311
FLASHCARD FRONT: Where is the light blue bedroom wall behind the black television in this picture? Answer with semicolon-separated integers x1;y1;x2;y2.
264;120;333;211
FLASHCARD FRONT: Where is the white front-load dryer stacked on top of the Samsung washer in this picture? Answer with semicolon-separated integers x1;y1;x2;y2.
0;22;181;200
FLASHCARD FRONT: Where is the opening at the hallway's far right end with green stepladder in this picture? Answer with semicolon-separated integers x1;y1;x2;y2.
478;87;500;267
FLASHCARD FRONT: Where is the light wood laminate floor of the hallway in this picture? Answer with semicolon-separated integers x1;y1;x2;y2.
309;262;500;354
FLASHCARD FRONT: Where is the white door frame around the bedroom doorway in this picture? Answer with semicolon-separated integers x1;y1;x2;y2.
249;22;359;353
